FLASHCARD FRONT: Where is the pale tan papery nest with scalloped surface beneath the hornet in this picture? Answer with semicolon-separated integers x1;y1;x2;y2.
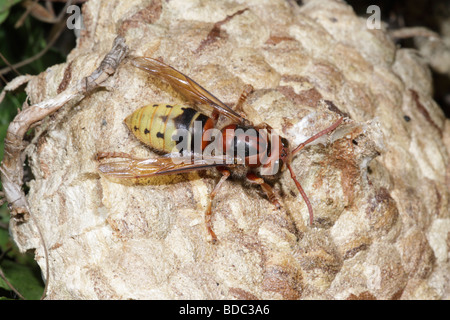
12;0;450;299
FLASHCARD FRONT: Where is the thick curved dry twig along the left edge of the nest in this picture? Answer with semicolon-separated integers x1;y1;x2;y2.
0;37;128;295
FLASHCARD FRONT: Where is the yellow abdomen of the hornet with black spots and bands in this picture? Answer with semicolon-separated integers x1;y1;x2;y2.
124;104;214;153
